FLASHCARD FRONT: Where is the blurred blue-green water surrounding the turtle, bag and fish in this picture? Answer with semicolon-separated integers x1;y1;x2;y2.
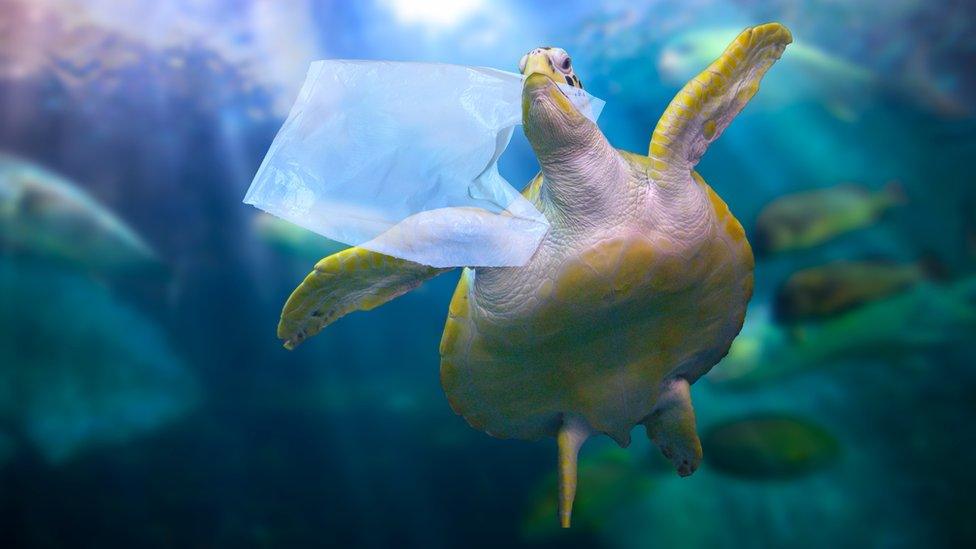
0;0;976;547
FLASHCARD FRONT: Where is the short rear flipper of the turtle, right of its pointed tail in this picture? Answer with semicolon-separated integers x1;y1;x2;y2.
643;378;702;477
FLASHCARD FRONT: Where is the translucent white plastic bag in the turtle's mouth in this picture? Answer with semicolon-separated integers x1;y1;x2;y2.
244;60;604;267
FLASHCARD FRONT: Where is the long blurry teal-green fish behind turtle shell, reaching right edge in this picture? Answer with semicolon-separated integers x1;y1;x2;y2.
707;276;976;388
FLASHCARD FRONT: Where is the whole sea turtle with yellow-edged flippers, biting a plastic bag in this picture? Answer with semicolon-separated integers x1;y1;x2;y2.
278;23;792;527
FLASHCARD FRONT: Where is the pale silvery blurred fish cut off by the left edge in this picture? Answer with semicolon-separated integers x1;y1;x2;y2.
0;155;160;274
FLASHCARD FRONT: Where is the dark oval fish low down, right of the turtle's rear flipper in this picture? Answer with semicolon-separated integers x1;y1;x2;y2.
702;413;841;480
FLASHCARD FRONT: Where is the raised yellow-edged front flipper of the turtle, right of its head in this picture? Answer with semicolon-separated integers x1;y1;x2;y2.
648;23;793;181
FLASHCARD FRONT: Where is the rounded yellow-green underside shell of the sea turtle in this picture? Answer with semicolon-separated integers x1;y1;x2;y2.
441;173;753;444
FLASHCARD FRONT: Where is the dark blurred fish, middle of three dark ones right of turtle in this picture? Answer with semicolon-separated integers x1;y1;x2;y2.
773;258;942;324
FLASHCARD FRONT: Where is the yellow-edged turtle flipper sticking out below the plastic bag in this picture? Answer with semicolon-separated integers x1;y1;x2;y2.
278;247;451;349
